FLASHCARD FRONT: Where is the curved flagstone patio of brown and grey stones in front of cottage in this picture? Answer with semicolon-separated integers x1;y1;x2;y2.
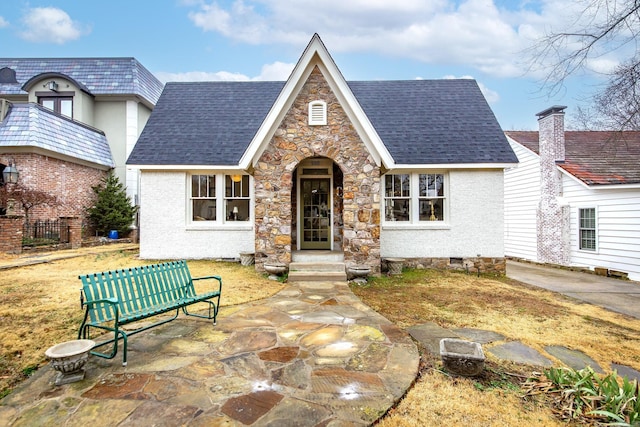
0;282;419;427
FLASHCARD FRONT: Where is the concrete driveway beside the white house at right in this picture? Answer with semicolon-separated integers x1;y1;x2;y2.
507;261;640;319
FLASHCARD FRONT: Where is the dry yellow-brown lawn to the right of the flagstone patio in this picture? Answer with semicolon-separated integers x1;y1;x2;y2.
352;270;640;427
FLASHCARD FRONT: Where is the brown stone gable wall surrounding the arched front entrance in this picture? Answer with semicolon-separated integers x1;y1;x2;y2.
254;67;380;273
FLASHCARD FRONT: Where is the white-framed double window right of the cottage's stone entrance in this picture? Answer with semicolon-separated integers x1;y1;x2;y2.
383;172;447;224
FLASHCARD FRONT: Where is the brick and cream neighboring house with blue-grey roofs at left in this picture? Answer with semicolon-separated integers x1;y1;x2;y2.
0;58;162;227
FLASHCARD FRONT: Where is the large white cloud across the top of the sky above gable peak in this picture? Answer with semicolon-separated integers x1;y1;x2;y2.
184;0;632;77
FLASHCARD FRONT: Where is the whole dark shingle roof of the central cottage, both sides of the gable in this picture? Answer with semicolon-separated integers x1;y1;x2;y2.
127;79;517;165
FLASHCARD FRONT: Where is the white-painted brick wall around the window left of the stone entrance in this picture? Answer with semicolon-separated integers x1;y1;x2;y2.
140;171;254;259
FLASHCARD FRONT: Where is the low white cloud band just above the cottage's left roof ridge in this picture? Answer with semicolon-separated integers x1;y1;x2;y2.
154;62;295;83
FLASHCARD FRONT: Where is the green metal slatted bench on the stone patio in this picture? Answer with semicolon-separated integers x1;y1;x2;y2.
78;260;222;366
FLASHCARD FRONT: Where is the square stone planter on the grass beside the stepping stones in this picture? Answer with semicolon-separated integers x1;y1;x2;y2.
440;338;485;377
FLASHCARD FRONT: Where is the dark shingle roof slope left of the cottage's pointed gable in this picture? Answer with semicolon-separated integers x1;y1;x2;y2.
127;82;284;166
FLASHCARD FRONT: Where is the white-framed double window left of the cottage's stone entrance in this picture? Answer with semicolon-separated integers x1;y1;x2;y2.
188;174;251;225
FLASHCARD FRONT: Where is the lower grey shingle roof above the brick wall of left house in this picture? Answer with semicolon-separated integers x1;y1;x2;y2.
0;103;115;168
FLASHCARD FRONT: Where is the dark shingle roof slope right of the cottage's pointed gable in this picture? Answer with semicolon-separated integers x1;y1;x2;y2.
349;79;517;165
